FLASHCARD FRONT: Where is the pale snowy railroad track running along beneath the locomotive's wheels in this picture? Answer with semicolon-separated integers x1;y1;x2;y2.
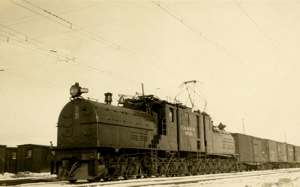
8;168;300;187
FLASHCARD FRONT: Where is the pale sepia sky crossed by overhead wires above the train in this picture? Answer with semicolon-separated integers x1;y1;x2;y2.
0;0;300;146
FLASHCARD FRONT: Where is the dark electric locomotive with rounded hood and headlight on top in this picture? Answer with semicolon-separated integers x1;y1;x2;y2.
55;83;236;182
